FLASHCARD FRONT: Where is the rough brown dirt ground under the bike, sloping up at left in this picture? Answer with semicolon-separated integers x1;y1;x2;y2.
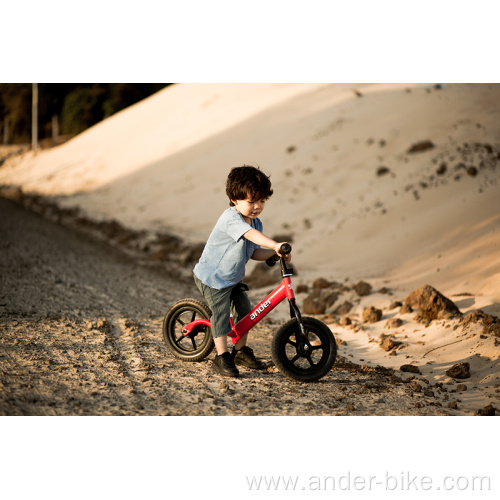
0;198;454;415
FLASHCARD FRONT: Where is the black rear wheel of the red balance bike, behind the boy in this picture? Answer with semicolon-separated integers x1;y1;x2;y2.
163;299;215;361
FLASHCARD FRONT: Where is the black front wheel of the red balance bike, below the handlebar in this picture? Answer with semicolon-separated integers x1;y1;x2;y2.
271;316;337;382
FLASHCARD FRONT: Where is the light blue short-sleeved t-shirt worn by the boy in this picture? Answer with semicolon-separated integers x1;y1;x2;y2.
193;207;262;290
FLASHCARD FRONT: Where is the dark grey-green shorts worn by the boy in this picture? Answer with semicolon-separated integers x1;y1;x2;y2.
193;275;252;339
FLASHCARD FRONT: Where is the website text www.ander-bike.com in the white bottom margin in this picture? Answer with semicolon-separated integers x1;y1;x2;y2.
246;471;492;492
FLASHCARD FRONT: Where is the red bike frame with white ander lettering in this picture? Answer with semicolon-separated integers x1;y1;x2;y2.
182;268;294;345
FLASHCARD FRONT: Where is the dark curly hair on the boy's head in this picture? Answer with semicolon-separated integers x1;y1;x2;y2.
226;165;273;206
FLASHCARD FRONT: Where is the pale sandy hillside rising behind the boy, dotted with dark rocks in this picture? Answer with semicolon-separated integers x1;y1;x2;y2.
0;84;500;411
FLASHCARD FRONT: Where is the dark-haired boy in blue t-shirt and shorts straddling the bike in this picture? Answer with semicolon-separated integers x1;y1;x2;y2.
193;165;291;377
